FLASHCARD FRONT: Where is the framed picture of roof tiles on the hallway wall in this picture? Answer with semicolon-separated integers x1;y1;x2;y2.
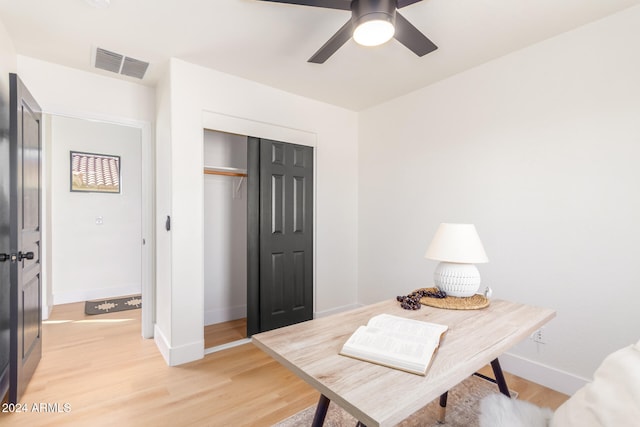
70;151;120;193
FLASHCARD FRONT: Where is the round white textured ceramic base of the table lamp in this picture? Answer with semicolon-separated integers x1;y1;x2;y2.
433;262;480;297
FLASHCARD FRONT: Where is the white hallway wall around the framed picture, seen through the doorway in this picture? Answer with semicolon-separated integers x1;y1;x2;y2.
50;116;142;304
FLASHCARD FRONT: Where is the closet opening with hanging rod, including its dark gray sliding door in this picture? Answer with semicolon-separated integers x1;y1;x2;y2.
203;129;314;354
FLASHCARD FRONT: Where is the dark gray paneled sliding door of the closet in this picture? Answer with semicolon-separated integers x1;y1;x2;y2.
247;138;313;335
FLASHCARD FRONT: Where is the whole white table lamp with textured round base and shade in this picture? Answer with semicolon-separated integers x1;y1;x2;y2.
424;223;489;297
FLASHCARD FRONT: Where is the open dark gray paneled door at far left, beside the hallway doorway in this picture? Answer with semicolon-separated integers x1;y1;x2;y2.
9;74;42;402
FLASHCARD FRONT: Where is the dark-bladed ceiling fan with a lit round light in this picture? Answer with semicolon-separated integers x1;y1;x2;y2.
261;0;438;64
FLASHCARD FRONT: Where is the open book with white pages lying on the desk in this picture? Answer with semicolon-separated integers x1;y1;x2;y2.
340;314;448;375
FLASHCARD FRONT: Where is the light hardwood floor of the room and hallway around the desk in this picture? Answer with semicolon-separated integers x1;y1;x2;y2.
0;303;567;427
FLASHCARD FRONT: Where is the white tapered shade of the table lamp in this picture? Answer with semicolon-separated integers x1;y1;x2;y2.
424;223;489;264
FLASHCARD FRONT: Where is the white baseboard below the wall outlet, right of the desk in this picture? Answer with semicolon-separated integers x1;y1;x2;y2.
500;353;590;396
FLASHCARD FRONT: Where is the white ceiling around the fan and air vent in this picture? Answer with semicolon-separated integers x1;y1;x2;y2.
0;0;640;111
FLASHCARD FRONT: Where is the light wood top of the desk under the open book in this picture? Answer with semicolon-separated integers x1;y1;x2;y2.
252;300;555;427
